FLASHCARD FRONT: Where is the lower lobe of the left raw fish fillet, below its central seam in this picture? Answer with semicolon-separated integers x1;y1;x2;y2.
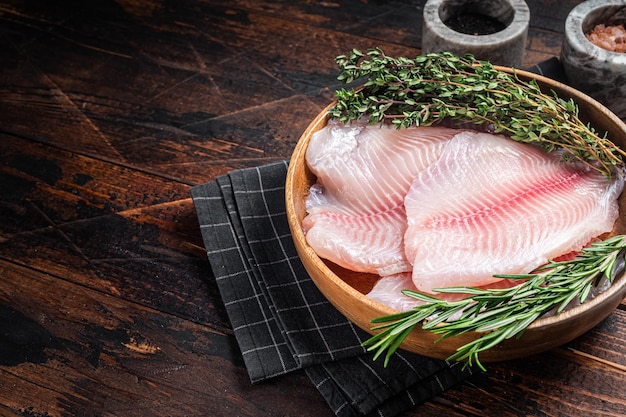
302;206;411;275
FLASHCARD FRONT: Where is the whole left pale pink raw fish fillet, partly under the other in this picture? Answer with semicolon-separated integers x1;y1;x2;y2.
303;121;458;275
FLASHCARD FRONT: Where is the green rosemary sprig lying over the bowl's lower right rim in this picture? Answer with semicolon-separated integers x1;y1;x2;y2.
363;235;626;370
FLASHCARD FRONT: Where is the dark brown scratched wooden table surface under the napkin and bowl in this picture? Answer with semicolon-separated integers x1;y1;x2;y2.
0;0;626;417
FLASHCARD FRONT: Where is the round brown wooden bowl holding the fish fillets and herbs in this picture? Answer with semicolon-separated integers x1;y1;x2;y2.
286;68;626;362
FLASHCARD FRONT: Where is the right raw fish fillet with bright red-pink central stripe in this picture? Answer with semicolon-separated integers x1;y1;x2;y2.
404;131;623;292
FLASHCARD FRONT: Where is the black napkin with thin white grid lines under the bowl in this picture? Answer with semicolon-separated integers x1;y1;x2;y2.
191;59;561;417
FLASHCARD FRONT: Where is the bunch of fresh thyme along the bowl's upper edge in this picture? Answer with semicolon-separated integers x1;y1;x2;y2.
330;49;626;177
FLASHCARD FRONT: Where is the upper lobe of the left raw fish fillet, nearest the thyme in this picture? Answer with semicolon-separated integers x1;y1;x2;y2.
306;120;459;216
